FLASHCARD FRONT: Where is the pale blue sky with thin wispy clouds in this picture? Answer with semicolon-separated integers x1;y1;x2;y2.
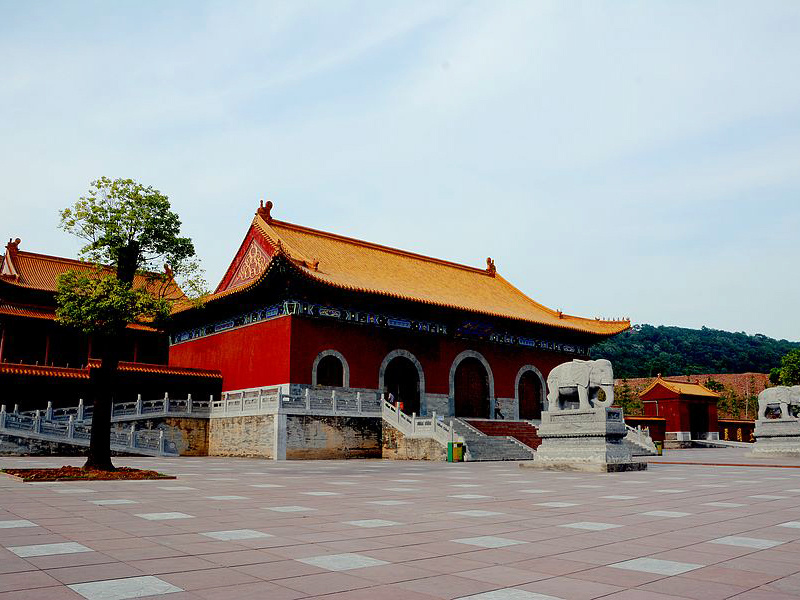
0;0;800;340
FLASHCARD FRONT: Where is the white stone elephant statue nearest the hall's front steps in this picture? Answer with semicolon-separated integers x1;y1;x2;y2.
547;358;614;411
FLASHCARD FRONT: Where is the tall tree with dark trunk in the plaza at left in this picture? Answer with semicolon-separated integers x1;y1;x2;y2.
56;177;204;470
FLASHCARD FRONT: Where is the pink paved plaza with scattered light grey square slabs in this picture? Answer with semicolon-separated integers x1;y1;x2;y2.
0;448;800;600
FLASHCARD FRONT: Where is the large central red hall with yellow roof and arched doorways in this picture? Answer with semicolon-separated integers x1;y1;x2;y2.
169;202;630;429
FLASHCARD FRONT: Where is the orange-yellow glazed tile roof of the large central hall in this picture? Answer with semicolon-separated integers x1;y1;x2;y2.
192;206;630;335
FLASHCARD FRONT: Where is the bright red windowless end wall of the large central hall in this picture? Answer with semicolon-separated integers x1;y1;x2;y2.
169;317;291;391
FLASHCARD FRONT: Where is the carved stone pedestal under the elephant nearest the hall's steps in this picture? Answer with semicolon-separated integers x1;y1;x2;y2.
521;406;647;473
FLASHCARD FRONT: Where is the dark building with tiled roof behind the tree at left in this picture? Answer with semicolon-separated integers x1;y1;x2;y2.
0;239;222;411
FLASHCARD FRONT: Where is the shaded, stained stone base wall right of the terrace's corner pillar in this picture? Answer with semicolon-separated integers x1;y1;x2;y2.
286;415;382;460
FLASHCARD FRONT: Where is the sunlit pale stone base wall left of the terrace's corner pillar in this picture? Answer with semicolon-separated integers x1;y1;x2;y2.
208;415;275;458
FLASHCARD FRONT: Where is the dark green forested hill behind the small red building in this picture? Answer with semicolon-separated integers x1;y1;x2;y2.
591;325;800;378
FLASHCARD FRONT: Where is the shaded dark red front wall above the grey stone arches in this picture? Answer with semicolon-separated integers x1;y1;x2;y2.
290;318;573;398
